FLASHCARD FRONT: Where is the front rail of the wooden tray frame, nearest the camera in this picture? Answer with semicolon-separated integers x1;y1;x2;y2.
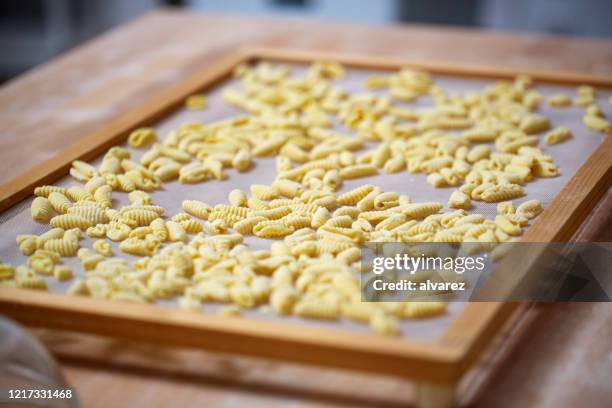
0;288;460;382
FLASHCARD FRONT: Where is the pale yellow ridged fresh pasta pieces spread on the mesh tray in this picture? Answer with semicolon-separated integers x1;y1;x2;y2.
0;62;610;335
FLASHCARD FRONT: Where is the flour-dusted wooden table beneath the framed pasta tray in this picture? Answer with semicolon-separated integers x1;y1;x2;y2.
0;10;612;407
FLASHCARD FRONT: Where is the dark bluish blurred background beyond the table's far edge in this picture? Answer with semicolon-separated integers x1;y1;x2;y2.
0;0;612;82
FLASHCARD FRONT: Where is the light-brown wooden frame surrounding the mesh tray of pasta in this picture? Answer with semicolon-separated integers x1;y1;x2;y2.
0;49;612;405
